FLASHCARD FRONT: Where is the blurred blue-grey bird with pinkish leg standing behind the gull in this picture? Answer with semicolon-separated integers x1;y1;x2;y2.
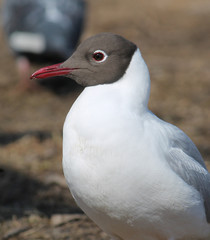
2;0;86;93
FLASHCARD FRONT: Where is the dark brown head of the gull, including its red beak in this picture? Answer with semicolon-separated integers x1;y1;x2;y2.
31;33;137;87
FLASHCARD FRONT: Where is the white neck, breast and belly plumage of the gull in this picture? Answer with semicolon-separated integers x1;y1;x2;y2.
63;48;209;240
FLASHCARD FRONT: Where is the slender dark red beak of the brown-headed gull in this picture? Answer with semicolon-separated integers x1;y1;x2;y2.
30;63;76;79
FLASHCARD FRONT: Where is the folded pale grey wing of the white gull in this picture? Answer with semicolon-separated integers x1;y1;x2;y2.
167;129;210;223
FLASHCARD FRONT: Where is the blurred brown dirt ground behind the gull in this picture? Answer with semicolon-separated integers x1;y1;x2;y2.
0;0;210;240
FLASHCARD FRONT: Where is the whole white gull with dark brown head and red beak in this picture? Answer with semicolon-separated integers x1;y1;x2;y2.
32;33;210;240
